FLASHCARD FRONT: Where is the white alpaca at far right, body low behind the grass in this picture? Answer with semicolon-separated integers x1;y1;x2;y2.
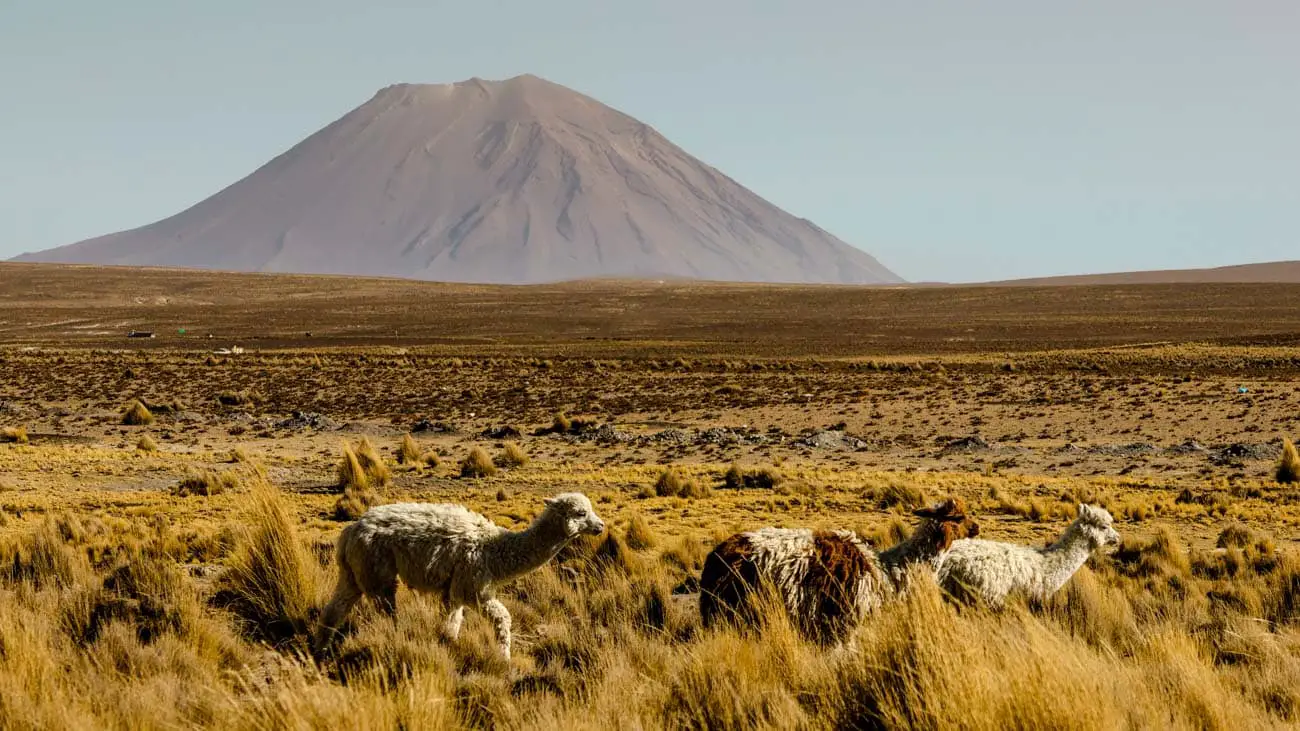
936;503;1119;607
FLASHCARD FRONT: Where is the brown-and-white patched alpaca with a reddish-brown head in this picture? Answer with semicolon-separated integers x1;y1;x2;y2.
699;499;979;645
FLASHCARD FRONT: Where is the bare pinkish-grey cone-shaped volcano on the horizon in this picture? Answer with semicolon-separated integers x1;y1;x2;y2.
17;75;901;284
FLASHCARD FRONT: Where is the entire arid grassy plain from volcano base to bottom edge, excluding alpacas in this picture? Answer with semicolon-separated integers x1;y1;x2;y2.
0;264;1300;728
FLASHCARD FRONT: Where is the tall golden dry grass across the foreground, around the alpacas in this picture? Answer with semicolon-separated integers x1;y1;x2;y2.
0;466;1300;728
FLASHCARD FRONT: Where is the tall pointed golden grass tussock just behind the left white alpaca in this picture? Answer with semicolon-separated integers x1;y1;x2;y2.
217;480;321;644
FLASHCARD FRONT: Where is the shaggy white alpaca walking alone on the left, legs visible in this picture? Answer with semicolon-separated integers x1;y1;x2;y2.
316;493;605;659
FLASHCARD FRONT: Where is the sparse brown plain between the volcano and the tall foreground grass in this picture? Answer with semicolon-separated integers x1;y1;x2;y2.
0;264;1300;551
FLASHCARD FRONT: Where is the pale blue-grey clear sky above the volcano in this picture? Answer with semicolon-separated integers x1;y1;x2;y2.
0;0;1300;281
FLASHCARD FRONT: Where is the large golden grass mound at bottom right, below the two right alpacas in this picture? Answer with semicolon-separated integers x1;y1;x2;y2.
816;581;1206;728
